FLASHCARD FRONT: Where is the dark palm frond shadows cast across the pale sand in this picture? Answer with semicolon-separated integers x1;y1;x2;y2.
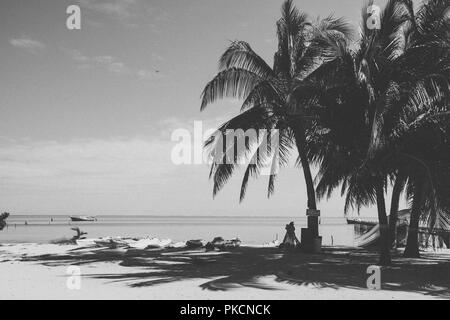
23;247;450;298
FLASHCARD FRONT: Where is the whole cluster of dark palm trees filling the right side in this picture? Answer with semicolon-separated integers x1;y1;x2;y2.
201;0;450;264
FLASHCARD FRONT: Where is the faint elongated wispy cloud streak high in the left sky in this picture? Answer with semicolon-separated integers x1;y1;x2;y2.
63;49;163;80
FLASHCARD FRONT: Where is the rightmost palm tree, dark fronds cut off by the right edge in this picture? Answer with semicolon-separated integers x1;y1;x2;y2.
372;0;450;257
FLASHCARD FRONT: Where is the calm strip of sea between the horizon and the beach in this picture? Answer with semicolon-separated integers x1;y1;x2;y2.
0;215;354;246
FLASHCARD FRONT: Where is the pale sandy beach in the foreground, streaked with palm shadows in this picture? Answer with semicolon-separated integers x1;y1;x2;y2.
0;244;450;300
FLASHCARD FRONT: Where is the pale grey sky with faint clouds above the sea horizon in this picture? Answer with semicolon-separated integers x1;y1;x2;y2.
0;0;408;216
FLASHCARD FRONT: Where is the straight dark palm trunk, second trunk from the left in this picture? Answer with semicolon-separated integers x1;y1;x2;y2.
375;181;391;266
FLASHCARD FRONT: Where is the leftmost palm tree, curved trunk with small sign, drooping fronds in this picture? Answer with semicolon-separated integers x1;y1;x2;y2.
201;0;351;245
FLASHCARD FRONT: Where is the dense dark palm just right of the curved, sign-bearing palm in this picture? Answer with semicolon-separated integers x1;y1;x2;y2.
294;0;418;264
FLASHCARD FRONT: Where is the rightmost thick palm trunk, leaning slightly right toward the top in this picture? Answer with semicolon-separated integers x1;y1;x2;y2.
403;182;423;258
